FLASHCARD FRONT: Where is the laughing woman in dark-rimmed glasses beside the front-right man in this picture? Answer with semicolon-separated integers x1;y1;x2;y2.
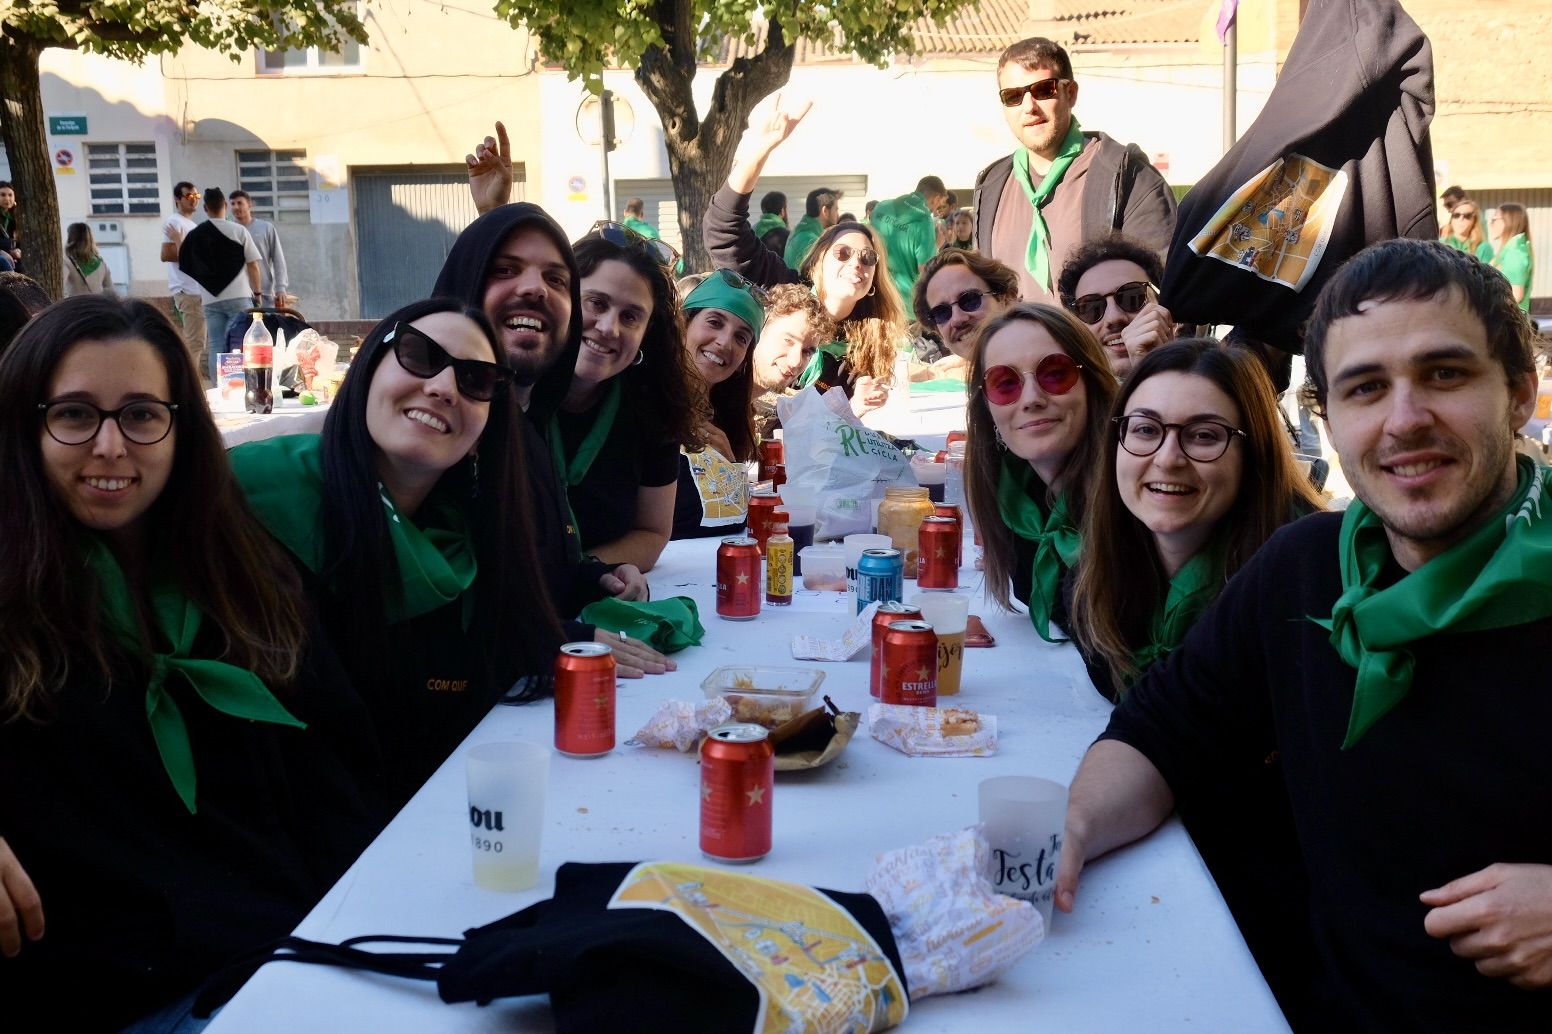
1072;338;1324;699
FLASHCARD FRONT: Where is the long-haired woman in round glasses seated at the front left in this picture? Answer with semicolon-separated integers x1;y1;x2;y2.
0;295;374;1031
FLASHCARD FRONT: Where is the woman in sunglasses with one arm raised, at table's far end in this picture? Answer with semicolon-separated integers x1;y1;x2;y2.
702;98;905;416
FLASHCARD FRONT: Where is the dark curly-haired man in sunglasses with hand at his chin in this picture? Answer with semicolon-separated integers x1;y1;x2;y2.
1057;234;1175;380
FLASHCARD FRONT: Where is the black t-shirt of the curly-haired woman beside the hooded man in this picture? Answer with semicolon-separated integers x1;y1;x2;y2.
556;391;678;550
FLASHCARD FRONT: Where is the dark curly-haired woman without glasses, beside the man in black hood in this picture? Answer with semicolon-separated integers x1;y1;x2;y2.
536;228;717;571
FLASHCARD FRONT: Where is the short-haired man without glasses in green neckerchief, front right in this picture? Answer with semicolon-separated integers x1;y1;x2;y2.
1055;239;1552;1034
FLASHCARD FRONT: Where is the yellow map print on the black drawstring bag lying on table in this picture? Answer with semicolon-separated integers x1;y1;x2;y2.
608;862;909;1034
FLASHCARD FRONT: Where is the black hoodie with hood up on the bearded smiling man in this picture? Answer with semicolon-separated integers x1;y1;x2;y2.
431;202;613;627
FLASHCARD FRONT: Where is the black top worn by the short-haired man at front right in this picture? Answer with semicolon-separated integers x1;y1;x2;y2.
1103;514;1552;1032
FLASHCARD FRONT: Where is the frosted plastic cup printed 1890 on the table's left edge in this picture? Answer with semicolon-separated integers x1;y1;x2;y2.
464;741;549;891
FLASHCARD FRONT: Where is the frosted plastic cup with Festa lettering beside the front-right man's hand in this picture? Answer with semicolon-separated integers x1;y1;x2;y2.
979;776;1066;930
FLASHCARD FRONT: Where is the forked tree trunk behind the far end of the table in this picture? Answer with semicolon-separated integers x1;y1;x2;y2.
635;7;796;273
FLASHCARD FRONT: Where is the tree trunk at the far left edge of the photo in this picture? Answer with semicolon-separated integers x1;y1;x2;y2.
0;33;64;298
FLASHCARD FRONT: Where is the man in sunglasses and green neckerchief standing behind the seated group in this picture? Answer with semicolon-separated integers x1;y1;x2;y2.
975;36;1175;303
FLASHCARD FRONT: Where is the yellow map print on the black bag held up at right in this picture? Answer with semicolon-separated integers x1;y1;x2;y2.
1190;154;1347;290
